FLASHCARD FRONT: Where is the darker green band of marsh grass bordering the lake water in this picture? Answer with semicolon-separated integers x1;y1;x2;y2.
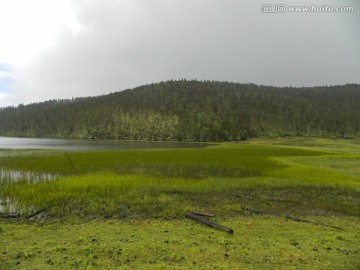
0;144;323;178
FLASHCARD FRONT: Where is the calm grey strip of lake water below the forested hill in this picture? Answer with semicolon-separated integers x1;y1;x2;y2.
0;137;210;150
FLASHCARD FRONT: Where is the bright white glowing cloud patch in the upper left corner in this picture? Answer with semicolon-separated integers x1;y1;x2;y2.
0;0;80;67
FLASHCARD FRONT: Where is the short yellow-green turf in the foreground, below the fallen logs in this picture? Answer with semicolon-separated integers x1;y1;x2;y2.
0;216;360;270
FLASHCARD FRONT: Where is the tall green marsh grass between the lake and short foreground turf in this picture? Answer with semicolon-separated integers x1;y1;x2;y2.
0;140;360;218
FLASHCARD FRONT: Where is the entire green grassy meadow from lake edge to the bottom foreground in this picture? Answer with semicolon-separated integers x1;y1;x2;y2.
0;138;360;269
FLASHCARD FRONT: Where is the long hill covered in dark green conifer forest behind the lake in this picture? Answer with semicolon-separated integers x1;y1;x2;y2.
0;80;360;141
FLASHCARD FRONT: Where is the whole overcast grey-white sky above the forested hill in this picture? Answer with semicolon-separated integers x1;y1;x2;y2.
0;0;360;107
